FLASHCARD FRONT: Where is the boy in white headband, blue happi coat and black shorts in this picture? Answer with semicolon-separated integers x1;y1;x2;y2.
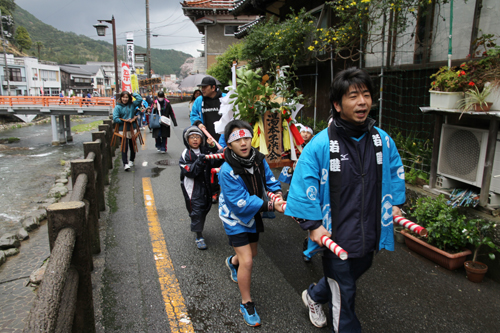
219;120;284;326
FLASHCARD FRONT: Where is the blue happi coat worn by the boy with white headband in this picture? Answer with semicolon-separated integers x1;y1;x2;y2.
219;160;281;235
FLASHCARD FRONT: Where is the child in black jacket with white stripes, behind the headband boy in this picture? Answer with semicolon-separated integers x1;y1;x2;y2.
179;126;220;250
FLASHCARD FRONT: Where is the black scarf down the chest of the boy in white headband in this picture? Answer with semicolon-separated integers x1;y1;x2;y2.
224;147;268;232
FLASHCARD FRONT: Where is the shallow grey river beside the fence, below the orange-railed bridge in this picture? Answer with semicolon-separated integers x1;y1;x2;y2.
0;117;108;236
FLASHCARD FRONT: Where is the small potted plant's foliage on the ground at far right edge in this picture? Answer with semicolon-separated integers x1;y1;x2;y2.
463;219;500;262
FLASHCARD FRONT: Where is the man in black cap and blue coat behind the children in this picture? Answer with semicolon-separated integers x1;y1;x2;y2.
189;76;226;141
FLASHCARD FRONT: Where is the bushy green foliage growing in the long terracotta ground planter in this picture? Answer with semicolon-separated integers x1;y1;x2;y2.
411;194;467;252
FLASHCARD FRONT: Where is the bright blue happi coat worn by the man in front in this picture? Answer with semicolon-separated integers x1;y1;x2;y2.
285;127;406;255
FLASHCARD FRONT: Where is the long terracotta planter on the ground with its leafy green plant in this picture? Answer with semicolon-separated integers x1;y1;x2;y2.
401;194;472;270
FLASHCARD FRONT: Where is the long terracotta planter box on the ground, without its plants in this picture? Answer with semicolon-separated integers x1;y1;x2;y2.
401;230;472;271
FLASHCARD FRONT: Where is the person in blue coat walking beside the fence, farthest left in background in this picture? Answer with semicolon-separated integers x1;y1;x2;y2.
113;91;142;171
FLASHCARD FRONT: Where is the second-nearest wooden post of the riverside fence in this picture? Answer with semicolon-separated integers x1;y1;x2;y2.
71;159;101;254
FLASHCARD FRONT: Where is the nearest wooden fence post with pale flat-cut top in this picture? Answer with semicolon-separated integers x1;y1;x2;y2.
46;200;95;332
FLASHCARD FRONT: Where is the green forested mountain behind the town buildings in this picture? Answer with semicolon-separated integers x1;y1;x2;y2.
13;6;192;75
